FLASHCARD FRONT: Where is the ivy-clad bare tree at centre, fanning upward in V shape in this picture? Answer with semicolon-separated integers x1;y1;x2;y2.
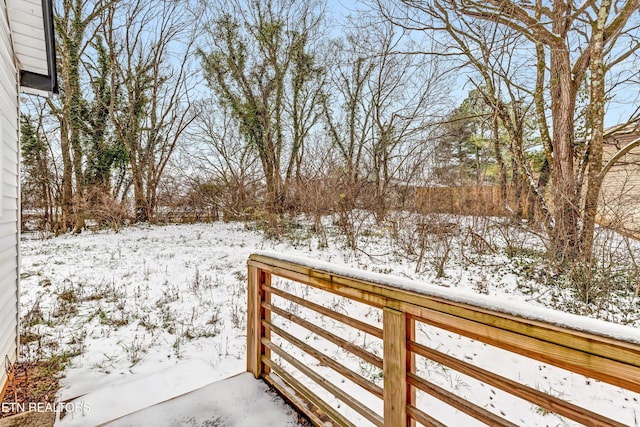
200;0;322;213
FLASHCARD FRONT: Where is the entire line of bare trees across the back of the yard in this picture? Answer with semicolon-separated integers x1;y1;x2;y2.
21;0;640;263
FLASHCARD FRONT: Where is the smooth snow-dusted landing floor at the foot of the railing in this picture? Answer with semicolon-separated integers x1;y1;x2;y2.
56;359;307;427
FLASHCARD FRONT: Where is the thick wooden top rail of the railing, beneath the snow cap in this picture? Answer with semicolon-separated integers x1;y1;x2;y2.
249;255;640;384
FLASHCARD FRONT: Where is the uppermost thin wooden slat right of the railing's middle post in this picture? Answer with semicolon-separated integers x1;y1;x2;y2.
407;342;617;426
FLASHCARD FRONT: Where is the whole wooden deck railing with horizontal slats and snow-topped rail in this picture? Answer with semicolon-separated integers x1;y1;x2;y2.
247;254;640;427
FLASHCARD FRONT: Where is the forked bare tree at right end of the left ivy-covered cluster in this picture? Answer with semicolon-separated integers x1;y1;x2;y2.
103;0;199;221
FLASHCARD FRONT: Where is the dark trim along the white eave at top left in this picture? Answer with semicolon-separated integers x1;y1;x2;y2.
20;0;59;94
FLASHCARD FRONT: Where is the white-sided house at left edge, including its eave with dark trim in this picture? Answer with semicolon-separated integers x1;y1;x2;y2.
0;0;57;396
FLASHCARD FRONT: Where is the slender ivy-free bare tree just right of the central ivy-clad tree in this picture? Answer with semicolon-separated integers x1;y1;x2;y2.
326;17;446;220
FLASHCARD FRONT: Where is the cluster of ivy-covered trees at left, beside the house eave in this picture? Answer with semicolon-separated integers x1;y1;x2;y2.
22;0;198;233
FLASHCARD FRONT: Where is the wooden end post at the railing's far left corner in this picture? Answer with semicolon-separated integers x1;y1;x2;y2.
247;265;271;378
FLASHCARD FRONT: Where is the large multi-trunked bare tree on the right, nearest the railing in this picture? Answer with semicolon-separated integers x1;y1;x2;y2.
378;0;640;261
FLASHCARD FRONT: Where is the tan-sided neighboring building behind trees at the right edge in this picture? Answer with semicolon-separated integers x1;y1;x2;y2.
598;125;640;237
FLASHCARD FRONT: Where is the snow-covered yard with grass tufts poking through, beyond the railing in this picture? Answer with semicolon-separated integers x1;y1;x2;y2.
20;222;640;426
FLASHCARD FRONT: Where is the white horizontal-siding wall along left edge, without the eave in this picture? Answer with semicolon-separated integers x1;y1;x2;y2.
0;1;20;391
